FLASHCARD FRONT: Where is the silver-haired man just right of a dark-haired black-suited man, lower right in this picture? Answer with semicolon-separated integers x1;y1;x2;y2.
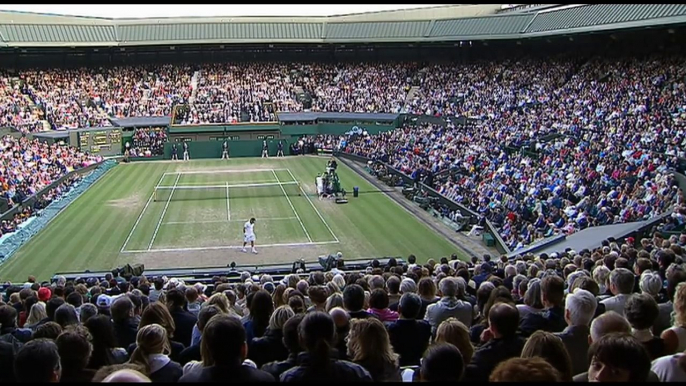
555;288;598;375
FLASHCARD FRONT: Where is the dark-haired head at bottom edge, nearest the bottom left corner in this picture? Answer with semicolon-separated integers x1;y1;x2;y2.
14;339;62;383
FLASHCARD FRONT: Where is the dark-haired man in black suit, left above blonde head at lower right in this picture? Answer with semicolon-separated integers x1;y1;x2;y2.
463;303;525;382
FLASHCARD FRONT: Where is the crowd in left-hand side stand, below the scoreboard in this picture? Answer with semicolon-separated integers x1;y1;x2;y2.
0;135;101;211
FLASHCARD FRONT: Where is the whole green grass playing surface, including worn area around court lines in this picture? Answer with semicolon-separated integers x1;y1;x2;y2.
0;157;463;282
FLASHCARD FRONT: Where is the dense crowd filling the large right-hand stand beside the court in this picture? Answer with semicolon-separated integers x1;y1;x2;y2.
345;52;686;250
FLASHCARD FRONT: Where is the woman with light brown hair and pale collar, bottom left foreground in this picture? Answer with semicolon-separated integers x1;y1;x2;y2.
129;324;183;382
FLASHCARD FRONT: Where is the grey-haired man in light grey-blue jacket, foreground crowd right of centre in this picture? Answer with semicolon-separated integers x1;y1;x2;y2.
424;277;474;334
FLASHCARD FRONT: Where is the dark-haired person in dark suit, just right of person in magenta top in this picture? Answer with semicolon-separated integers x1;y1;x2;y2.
386;293;431;366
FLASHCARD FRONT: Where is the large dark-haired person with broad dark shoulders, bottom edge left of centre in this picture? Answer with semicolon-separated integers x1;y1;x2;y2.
179;315;276;383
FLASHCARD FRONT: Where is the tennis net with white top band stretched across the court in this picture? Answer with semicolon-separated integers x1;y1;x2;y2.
154;181;302;202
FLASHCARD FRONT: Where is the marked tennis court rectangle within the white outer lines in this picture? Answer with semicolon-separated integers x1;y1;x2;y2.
121;168;339;253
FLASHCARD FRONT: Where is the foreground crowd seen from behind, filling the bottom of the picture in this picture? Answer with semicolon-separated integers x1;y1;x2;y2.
0;232;686;382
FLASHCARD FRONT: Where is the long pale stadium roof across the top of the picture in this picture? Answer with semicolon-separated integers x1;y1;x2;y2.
0;4;686;47
